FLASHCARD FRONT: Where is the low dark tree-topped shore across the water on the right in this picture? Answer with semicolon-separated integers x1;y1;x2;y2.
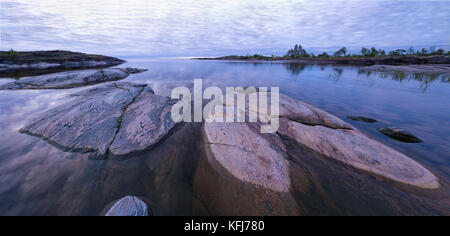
194;44;450;74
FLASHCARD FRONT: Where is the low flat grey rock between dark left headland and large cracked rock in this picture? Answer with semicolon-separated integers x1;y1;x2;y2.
0;68;145;90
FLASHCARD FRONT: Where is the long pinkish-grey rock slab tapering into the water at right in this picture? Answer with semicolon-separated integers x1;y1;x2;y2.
279;119;440;189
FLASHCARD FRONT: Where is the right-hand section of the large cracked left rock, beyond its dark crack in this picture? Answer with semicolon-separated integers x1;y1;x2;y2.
109;88;175;155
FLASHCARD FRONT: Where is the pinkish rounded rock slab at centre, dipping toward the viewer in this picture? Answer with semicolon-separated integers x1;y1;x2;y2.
204;122;290;192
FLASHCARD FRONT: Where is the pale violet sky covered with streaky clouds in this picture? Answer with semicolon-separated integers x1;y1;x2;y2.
0;0;450;57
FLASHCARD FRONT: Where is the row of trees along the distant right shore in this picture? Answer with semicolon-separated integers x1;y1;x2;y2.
237;44;450;59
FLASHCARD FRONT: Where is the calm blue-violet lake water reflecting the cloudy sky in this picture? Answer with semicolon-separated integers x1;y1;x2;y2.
0;58;450;215
